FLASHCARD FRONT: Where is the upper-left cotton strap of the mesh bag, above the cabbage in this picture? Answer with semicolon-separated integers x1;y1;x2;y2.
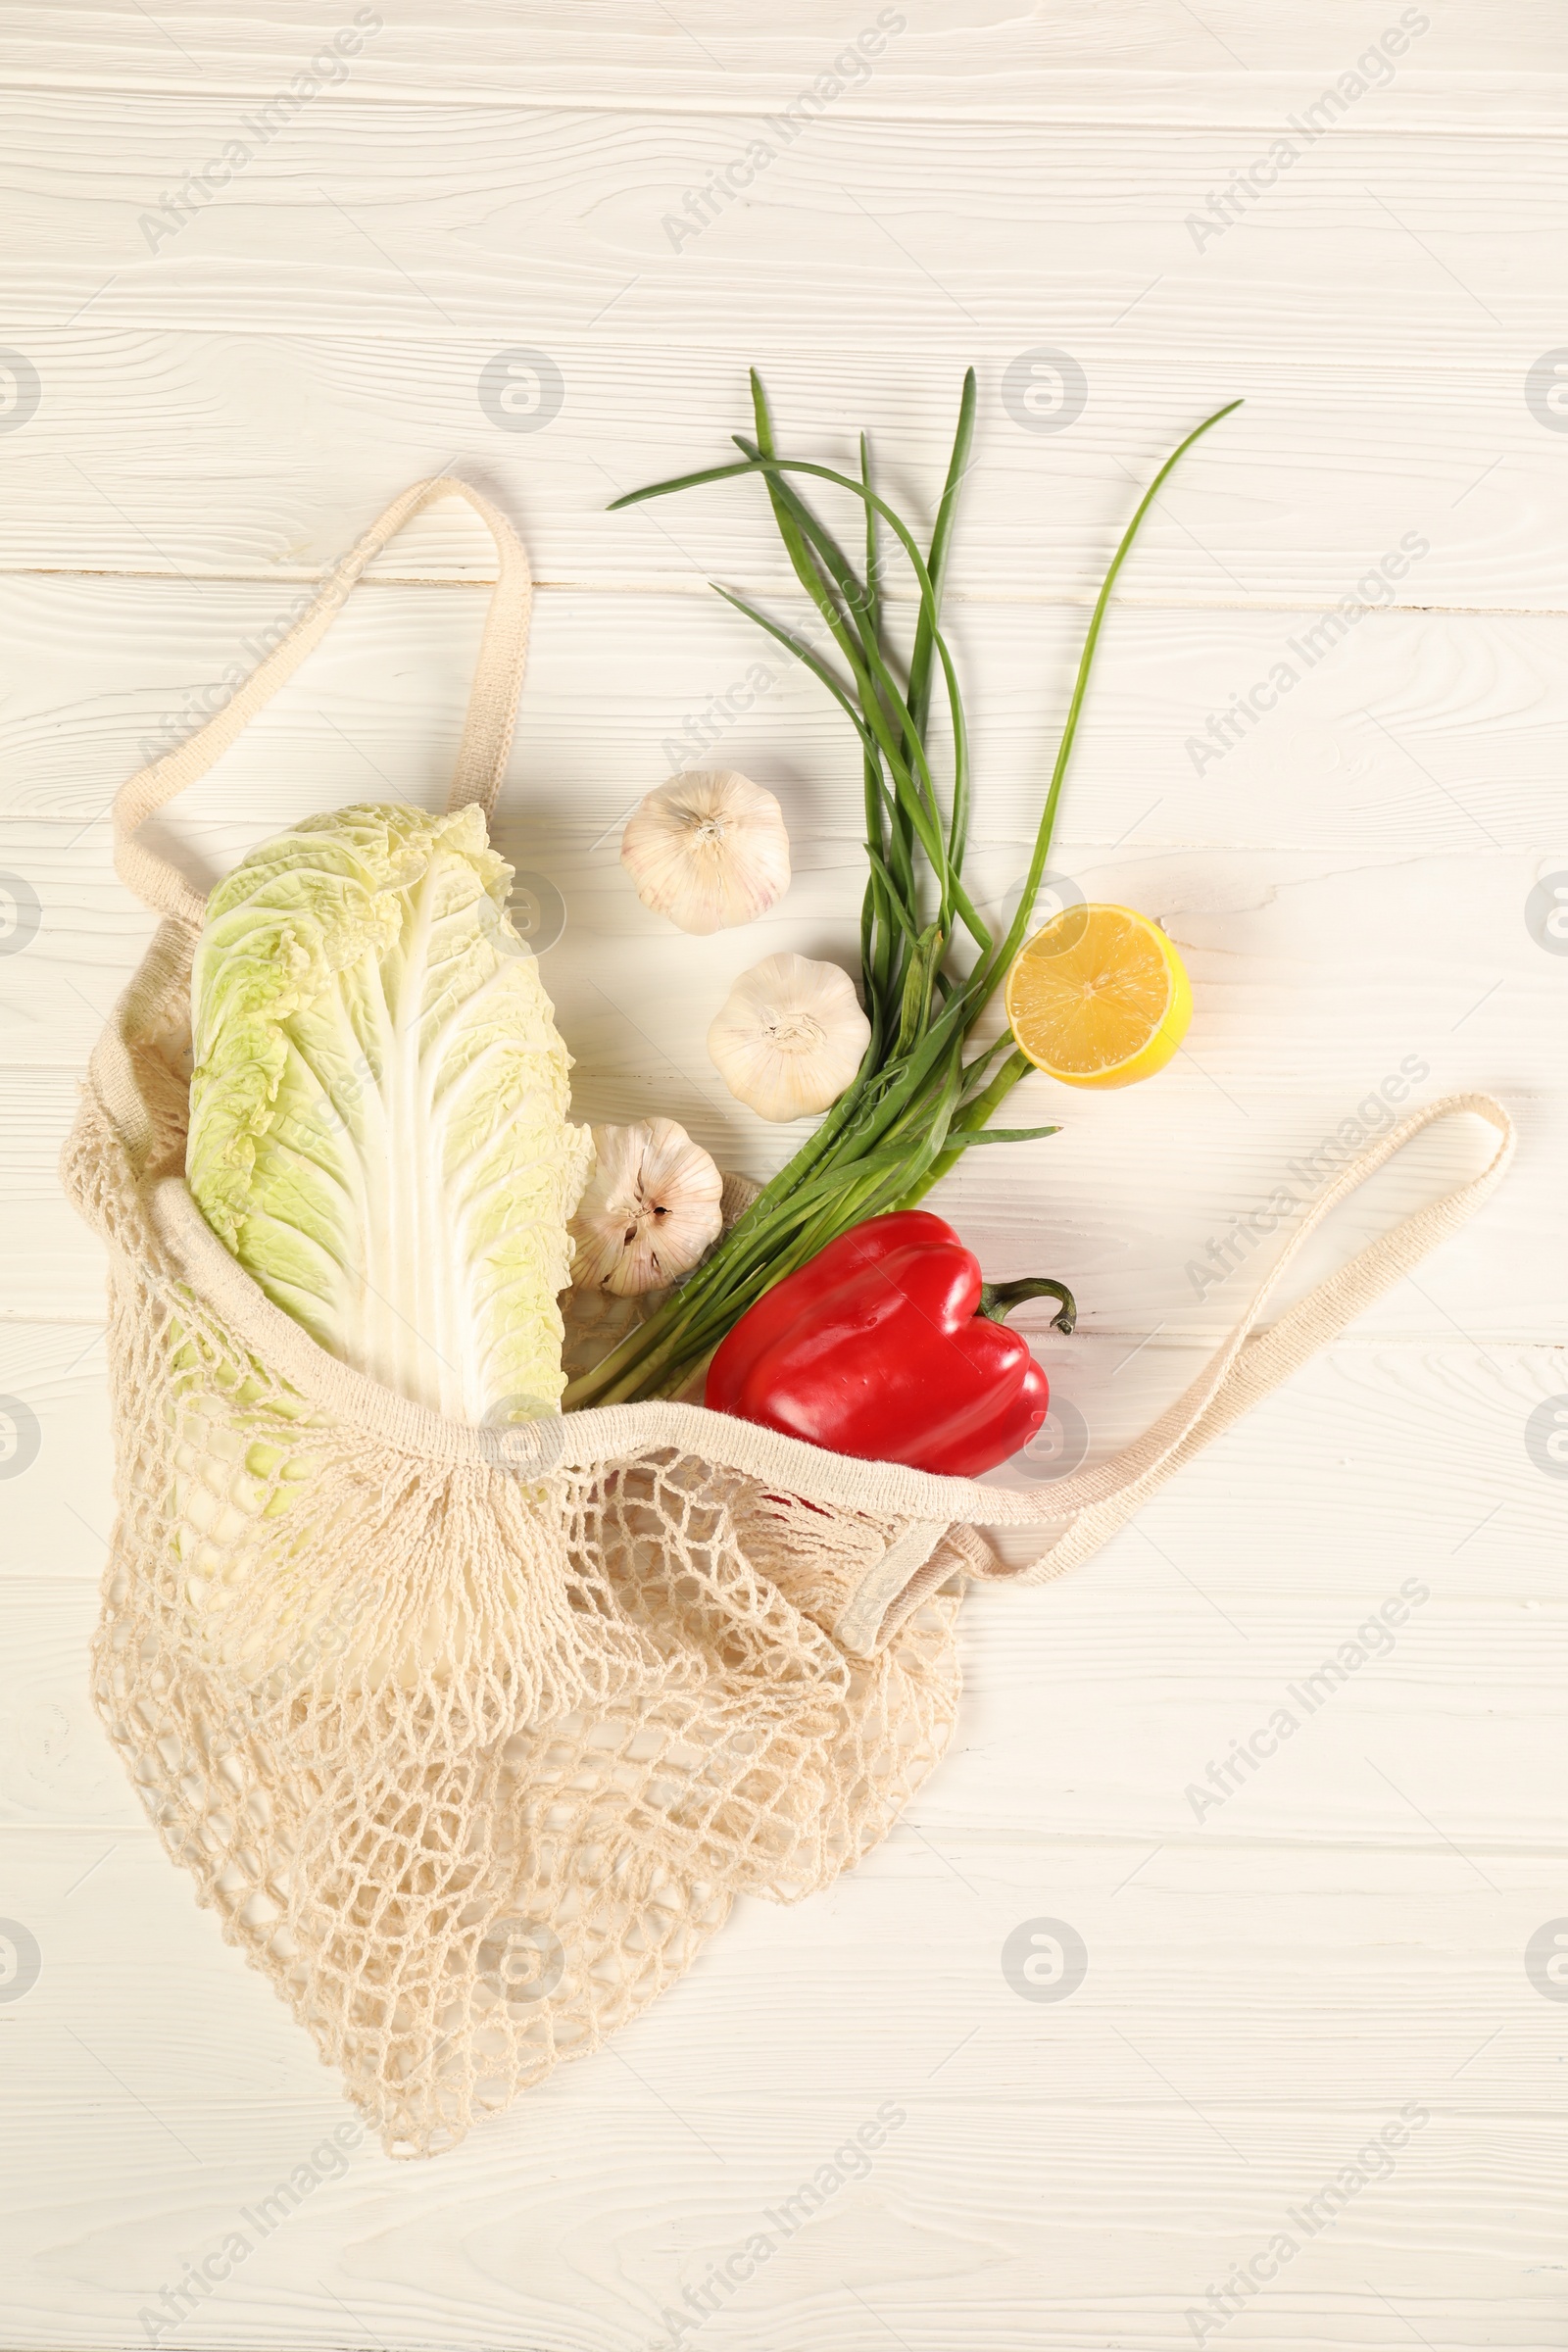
113;475;531;929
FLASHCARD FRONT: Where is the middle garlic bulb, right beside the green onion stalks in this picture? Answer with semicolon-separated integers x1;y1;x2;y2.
708;955;872;1119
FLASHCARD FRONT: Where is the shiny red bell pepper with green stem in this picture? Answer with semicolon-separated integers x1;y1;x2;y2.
703;1209;1077;1477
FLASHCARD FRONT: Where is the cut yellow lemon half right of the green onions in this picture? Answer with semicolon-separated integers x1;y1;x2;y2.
1006;906;1192;1087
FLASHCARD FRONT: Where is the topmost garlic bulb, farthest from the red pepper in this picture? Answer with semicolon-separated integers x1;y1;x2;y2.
620;766;790;931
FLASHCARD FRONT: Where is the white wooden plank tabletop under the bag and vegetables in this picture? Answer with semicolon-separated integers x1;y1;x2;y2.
0;0;1568;2352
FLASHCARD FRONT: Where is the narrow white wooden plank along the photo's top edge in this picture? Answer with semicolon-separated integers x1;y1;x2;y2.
7;0;1561;119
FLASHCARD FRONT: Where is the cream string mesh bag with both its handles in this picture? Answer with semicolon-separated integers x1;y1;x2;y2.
64;482;1511;2154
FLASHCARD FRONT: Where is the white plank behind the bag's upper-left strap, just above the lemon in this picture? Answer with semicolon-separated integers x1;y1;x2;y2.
0;578;1568;856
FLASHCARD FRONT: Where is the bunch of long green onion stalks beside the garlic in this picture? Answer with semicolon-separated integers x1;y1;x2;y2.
562;369;1242;1411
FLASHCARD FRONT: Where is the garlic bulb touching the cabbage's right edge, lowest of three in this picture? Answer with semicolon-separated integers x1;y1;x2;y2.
569;1119;724;1298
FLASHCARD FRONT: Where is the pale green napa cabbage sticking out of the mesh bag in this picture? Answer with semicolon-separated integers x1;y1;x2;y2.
186;807;592;1423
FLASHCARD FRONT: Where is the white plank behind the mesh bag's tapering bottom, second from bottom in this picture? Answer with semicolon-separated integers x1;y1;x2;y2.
0;1825;1561;2117
